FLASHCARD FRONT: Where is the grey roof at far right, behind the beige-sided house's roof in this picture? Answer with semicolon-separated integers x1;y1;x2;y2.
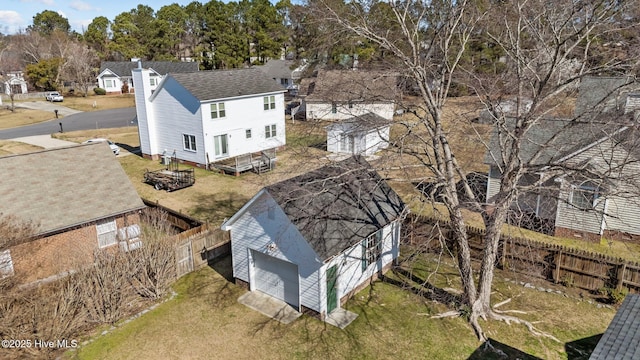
575;76;634;115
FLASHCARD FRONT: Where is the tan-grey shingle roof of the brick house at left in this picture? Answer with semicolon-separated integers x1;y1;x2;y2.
0;143;145;235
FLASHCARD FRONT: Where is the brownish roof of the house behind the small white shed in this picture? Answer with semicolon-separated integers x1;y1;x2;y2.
301;70;398;102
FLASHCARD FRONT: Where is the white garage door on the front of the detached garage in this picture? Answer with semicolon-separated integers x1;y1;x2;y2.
252;251;299;308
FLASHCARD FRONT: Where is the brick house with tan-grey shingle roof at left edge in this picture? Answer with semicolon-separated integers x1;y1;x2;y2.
0;143;145;283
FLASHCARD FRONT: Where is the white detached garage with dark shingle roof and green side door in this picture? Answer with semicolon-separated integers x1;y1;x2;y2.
222;156;406;319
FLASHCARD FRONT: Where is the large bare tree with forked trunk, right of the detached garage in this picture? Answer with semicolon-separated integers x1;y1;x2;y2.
310;0;630;340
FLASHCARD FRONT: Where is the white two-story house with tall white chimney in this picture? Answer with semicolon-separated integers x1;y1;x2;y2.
132;67;286;170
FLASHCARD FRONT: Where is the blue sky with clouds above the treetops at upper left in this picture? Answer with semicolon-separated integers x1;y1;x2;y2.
0;0;195;35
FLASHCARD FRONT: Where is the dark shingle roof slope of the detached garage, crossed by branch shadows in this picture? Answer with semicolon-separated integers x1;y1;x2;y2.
265;156;405;260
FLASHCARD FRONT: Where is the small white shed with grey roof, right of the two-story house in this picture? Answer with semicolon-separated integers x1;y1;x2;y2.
326;113;391;156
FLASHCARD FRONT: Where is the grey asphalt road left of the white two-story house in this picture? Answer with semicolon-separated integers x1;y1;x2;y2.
0;107;137;140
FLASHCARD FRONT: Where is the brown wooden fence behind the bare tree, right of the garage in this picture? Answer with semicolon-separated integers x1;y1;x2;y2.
404;215;640;293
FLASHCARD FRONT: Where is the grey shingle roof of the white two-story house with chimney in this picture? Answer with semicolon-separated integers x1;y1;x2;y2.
165;68;286;101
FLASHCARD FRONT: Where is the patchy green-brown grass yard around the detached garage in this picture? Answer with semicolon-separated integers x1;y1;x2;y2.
66;257;614;359
